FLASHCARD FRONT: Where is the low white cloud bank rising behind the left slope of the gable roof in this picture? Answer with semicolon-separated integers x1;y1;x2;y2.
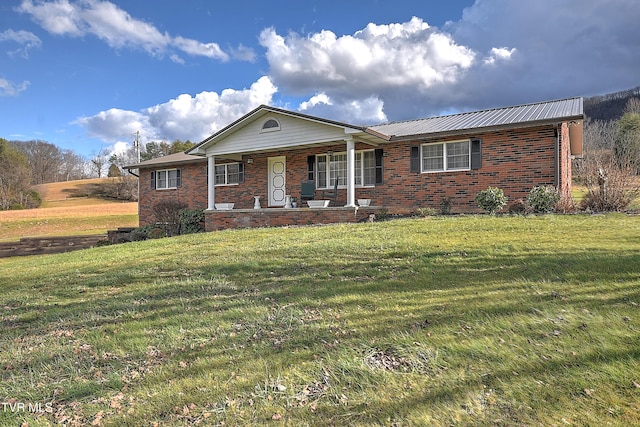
75;77;277;147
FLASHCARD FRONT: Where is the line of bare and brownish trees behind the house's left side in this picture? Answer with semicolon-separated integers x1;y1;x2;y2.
0;138;195;210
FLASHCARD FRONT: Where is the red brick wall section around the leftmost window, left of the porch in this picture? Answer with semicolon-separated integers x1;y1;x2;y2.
138;161;207;226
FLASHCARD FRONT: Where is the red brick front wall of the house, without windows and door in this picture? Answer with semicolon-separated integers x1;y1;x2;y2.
140;124;571;225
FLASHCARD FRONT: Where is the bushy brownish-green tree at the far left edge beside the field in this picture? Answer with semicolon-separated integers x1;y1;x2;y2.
0;138;37;210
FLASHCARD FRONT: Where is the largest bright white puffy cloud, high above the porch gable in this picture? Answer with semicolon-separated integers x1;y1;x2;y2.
260;17;475;97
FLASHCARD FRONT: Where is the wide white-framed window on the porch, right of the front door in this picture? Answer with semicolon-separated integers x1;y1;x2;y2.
316;150;382;188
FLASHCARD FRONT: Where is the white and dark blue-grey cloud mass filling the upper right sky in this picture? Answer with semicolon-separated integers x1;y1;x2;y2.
259;0;640;120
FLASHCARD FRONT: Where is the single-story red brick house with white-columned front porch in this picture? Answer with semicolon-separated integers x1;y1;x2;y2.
128;98;584;230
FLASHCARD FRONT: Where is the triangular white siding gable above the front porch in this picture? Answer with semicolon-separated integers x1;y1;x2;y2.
206;111;350;156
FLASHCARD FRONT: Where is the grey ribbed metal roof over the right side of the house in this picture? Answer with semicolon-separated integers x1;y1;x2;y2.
368;97;584;140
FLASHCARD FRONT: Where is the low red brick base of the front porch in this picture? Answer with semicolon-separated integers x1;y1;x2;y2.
205;206;384;231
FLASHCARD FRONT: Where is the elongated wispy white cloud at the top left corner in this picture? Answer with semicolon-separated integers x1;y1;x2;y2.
17;0;229;62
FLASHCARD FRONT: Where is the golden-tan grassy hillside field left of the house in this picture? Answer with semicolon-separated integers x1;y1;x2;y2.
0;178;138;241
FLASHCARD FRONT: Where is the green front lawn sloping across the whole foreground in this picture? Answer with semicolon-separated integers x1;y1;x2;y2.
0;214;640;426
